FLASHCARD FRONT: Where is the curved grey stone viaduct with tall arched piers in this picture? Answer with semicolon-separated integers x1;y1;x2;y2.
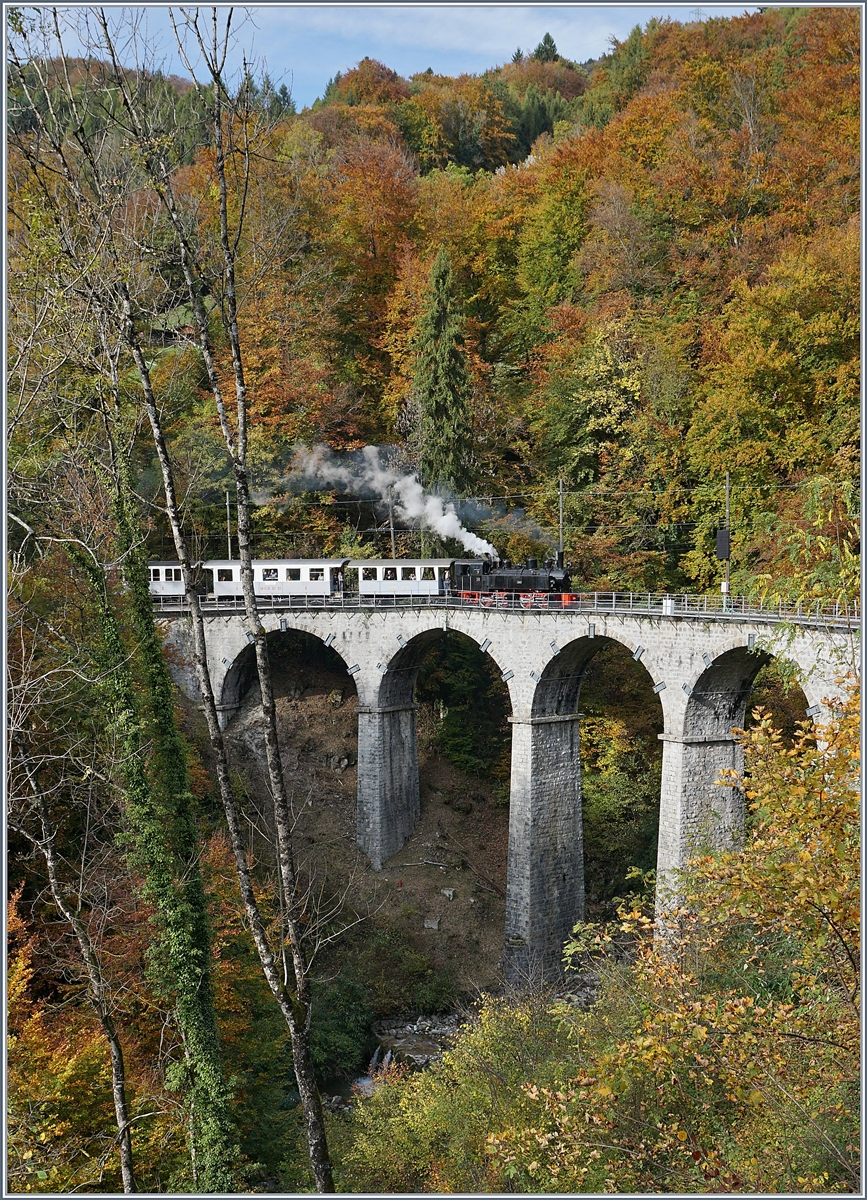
157;595;857;979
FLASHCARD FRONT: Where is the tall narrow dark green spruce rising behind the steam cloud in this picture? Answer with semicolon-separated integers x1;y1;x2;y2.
413;247;473;496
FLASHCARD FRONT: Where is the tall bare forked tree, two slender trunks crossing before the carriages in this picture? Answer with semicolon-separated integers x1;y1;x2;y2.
14;10;334;1192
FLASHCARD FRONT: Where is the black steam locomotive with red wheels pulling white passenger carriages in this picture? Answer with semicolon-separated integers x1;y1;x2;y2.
149;551;578;607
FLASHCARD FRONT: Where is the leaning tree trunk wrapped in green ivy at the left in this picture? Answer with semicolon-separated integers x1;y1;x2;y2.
8;46;238;1192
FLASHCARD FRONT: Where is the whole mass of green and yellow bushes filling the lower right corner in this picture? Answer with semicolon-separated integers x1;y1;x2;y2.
326;697;860;1194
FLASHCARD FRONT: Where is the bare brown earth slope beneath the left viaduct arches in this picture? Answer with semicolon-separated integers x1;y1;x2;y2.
214;655;508;998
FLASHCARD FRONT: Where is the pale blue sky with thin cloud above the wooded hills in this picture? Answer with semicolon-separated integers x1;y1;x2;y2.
42;0;755;109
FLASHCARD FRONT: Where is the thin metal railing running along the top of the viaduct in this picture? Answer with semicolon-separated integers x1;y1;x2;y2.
154;592;860;626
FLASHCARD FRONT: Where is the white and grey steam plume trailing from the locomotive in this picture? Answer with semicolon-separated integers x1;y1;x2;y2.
293;446;498;558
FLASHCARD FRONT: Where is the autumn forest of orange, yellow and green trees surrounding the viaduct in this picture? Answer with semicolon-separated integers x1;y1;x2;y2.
6;7;861;1194
